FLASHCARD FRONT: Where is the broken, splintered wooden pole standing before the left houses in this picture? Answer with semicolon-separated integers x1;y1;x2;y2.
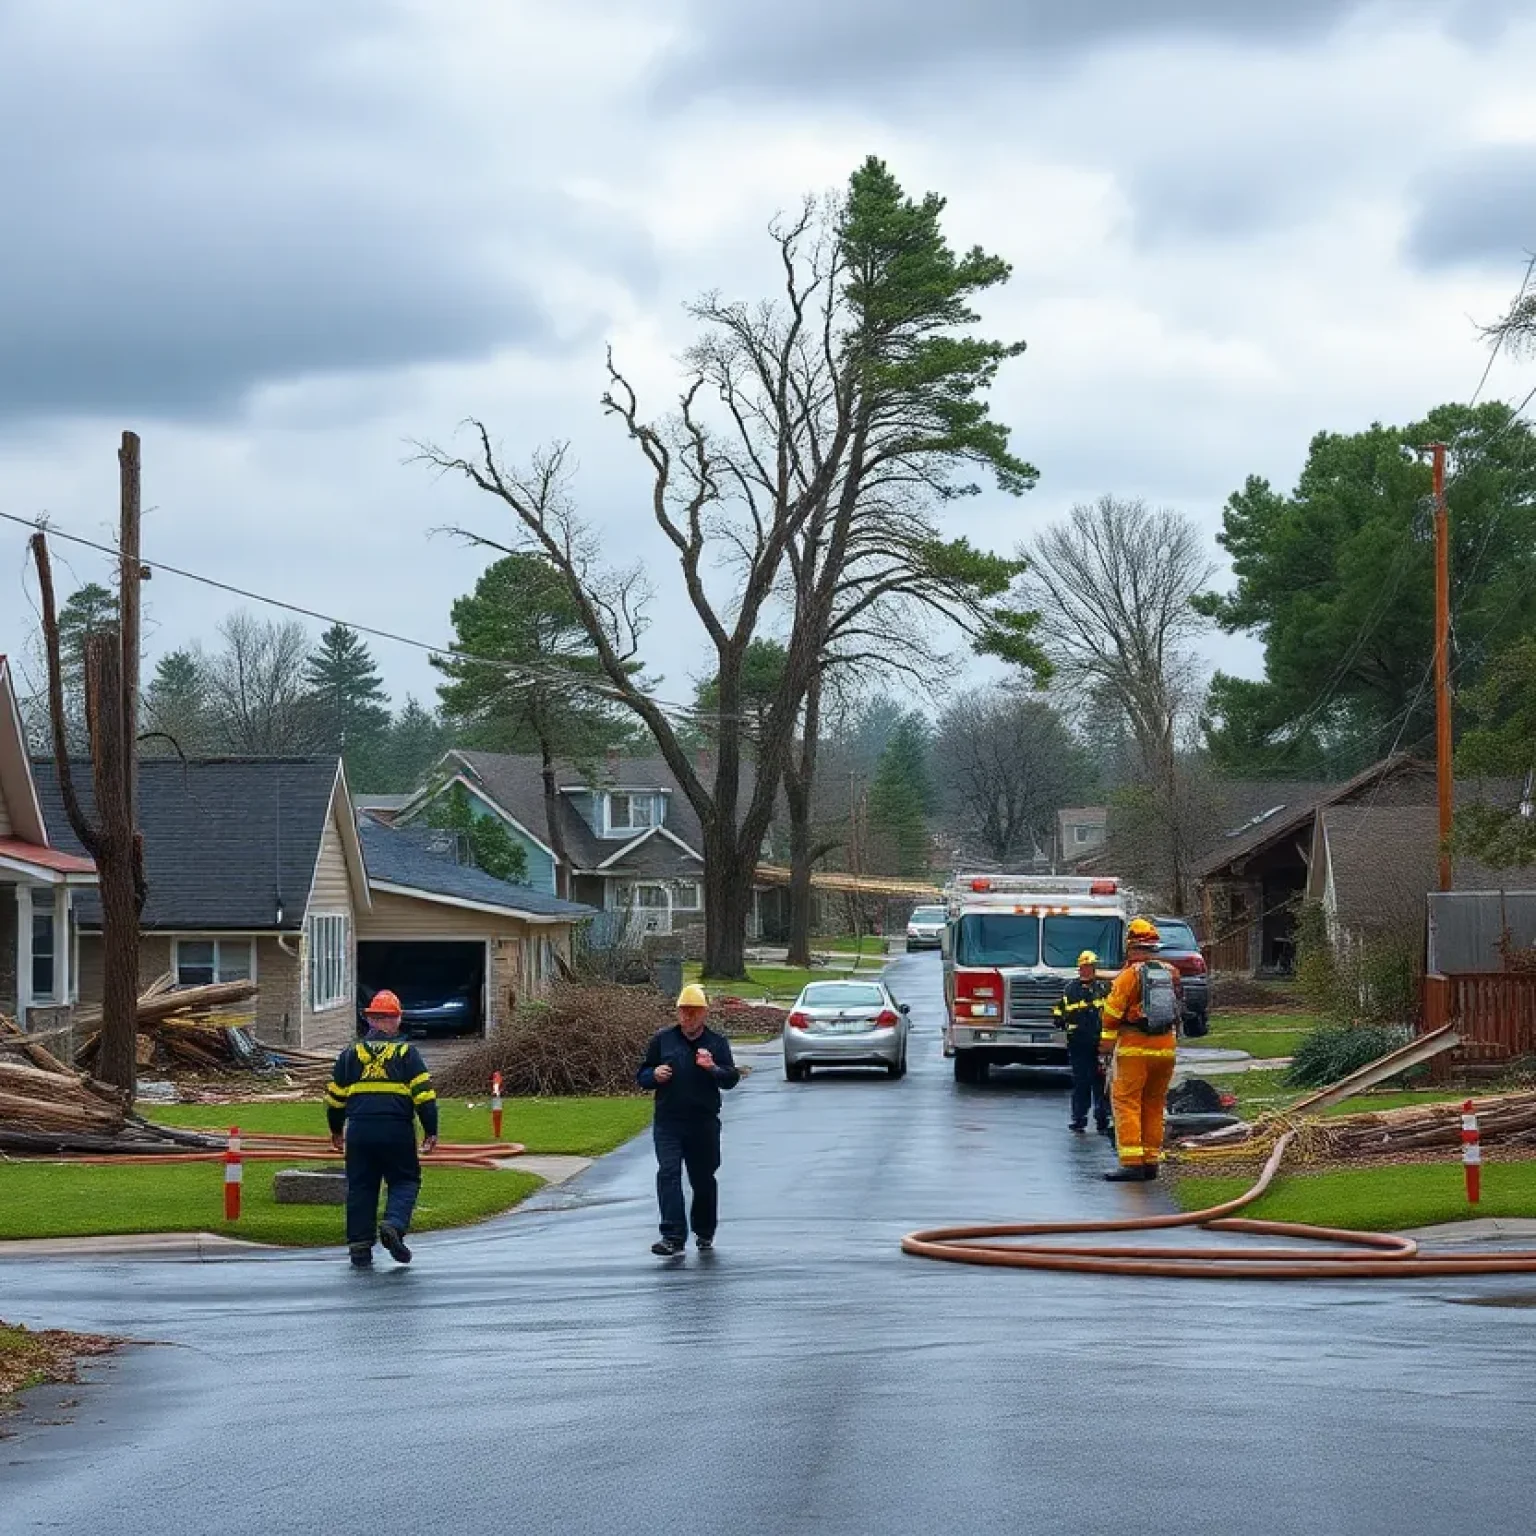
32;432;146;1095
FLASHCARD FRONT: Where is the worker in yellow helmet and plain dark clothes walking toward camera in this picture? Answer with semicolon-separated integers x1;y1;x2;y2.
636;983;742;1258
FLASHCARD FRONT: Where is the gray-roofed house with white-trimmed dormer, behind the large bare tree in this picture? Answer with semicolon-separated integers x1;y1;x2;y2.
395;751;743;934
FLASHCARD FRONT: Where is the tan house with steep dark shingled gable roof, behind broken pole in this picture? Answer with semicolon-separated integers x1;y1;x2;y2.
34;757;372;1049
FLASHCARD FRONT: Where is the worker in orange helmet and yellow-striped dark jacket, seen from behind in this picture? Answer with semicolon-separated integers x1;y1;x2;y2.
326;992;438;1269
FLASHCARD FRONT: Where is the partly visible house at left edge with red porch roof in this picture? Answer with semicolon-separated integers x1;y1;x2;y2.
0;656;97;1029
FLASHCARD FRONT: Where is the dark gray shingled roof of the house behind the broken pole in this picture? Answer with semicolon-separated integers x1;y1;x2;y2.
32;757;336;931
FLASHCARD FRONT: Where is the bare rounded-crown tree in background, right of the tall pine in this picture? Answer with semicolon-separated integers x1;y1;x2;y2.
1025;496;1215;911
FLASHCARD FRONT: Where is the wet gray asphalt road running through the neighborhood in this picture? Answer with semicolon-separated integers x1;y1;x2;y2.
0;955;1536;1536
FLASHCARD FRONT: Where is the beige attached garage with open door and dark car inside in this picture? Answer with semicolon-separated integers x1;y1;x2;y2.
358;816;596;1035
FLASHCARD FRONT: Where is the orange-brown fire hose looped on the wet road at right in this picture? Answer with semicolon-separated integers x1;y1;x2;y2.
902;1130;1536;1279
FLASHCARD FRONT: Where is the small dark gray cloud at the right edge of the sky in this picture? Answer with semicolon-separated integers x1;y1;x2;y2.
1409;144;1536;267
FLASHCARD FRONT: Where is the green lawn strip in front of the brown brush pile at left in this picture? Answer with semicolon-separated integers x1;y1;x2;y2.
146;1097;651;1157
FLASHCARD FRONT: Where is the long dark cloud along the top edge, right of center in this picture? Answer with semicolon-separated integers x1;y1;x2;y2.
676;0;1522;94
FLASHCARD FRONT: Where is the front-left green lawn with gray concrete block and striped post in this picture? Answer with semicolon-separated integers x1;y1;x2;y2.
0;1161;542;1247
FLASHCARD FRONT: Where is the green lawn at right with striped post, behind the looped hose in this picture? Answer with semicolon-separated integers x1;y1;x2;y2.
1175;1161;1536;1232
